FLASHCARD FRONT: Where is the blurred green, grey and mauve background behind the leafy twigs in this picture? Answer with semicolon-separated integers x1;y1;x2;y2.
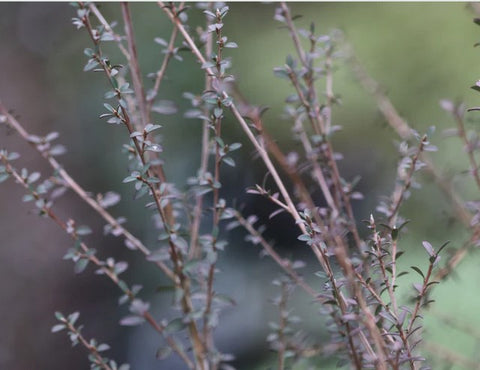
0;3;480;369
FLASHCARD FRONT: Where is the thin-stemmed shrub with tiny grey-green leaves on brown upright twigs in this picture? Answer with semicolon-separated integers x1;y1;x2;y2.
0;2;480;370
